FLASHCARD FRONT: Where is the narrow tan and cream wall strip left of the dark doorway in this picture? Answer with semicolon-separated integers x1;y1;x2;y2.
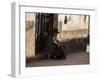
25;13;35;58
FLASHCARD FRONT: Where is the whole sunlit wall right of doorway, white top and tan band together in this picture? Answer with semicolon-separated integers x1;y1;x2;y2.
58;15;89;41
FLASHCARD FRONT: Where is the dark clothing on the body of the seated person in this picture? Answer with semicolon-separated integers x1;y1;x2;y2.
45;36;66;59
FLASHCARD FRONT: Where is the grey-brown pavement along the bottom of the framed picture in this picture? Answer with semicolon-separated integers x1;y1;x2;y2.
26;52;90;67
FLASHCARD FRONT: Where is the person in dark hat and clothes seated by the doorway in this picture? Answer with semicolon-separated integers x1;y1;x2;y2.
46;29;66;59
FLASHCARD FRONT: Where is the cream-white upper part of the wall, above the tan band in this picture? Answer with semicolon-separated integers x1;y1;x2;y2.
58;15;89;31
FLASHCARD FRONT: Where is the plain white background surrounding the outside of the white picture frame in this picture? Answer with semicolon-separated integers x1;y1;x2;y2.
0;0;100;80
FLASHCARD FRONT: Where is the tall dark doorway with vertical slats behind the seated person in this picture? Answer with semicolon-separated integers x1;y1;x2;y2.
35;13;54;54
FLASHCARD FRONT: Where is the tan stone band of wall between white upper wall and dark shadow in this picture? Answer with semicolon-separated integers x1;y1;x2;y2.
59;29;88;41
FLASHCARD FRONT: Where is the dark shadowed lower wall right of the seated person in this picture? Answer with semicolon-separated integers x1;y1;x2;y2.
62;37;89;53
